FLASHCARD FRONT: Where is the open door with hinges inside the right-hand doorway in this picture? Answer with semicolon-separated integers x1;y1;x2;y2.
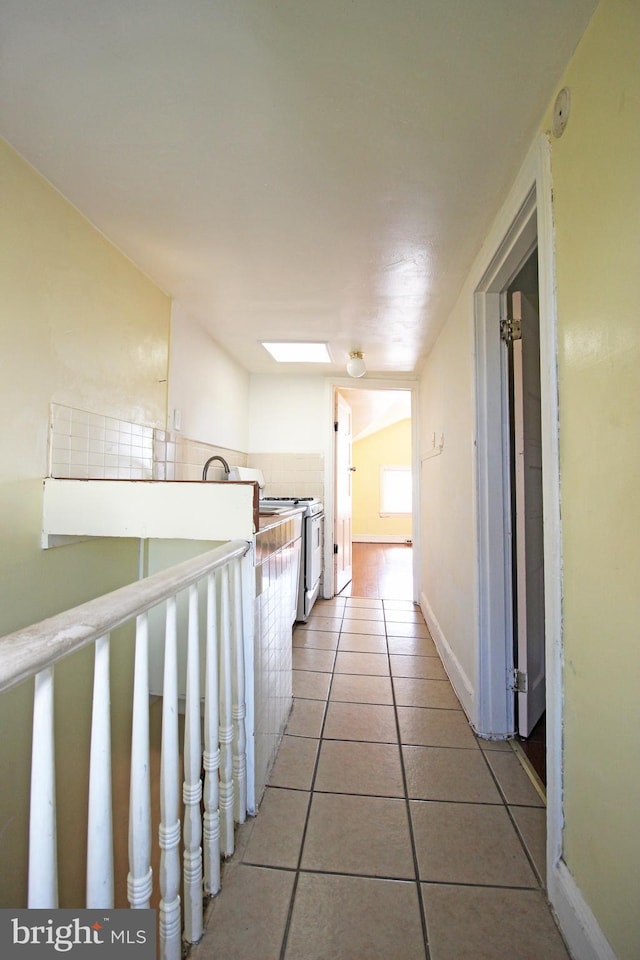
512;292;546;737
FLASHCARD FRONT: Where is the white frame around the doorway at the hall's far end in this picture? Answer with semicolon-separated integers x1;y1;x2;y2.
323;376;420;603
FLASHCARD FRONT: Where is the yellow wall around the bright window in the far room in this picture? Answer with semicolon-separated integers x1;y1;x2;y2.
352;420;411;538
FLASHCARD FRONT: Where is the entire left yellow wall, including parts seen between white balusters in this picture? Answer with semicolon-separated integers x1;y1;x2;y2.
0;142;170;906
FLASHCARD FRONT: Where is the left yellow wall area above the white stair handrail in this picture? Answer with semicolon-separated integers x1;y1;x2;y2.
0;142;170;635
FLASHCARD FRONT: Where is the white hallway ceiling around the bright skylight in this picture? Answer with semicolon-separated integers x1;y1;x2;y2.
0;0;596;377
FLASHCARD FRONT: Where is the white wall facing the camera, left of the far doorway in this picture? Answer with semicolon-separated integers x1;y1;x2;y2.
249;374;328;453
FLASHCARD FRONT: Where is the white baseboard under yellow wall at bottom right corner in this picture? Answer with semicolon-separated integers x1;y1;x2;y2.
548;860;616;960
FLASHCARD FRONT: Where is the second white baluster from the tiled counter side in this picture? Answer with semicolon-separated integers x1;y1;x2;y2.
219;567;234;857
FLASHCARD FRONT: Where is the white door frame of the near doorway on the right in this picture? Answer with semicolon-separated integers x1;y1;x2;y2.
473;136;563;902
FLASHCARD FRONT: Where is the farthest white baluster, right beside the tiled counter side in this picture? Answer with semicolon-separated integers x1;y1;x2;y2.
231;560;247;823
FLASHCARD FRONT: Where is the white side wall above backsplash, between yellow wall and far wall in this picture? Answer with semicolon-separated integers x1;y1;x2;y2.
167;302;249;452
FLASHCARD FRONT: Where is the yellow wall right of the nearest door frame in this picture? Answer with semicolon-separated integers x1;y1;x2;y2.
552;0;640;960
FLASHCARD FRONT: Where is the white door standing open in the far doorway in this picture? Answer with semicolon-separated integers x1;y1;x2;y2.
333;392;352;593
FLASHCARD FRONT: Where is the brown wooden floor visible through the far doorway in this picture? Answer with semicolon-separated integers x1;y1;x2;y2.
340;543;413;600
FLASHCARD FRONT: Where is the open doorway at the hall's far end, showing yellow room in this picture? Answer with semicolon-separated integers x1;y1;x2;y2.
332;381;415;599
